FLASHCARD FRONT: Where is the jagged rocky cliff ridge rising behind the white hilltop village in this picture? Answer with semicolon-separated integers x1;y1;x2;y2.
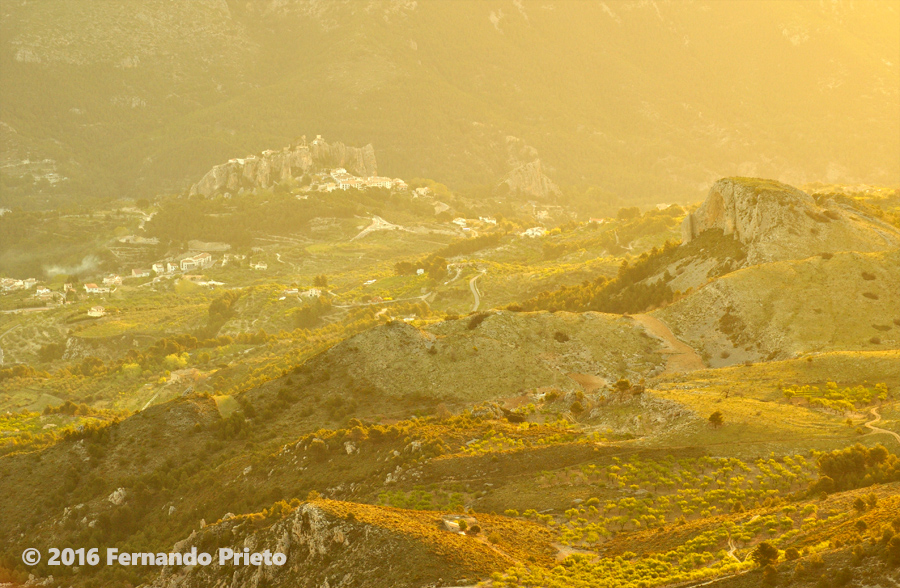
191;138;378;196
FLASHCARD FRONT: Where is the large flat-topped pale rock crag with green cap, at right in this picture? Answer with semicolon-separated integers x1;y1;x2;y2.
681;178;900;264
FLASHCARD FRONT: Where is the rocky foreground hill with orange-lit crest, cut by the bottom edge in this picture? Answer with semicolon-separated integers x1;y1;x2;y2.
145;501;502;588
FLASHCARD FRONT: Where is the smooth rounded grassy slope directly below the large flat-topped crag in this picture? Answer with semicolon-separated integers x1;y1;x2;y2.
653;250;900;367
